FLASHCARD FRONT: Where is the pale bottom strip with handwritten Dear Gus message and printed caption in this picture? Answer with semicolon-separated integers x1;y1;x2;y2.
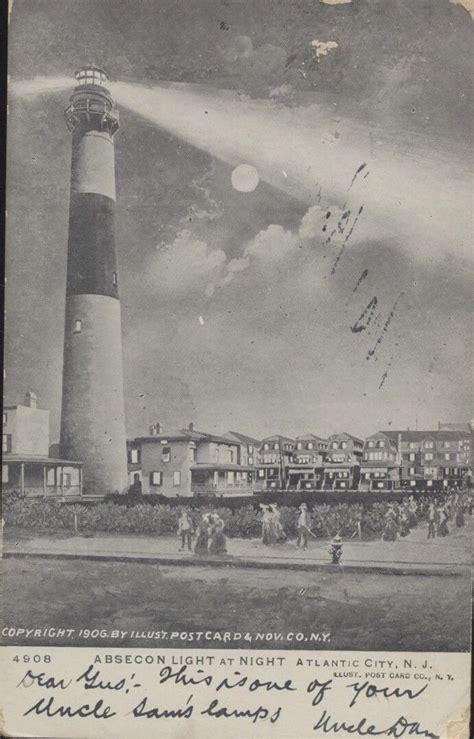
2;647;469;739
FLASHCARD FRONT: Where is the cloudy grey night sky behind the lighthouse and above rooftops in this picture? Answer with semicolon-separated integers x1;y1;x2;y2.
5;0;474;440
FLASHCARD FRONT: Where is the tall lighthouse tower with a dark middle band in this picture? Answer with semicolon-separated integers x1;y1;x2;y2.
60;65;127;494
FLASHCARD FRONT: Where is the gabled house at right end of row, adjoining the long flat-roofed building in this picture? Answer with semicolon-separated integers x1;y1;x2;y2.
359;431;400;491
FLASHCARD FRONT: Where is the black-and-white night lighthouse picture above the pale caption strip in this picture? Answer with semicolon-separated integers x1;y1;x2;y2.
1;0;474;664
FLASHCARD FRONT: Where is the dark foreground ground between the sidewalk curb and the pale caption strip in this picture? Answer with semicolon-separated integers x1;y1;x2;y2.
2;558;470;651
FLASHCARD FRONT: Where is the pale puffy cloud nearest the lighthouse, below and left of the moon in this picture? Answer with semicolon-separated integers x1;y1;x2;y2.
150;229;226;293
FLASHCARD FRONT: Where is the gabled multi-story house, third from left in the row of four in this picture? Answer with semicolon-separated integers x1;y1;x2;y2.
323;432;364;490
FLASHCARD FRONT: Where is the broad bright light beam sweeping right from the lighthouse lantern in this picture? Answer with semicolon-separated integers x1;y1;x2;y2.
111;82;472;261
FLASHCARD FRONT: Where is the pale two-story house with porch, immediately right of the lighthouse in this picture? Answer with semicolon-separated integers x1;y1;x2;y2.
128;424;255;497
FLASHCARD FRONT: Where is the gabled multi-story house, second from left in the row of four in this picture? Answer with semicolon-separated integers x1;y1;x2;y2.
288;434;328;490
